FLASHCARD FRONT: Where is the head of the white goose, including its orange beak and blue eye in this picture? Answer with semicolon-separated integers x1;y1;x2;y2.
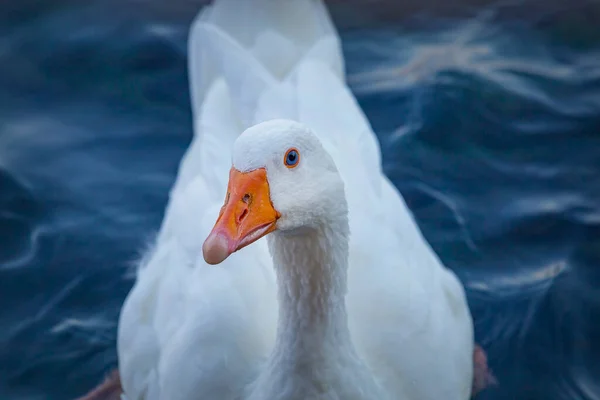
202;120;347;265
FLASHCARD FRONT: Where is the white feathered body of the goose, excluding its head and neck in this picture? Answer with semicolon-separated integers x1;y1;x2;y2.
118;0;473;400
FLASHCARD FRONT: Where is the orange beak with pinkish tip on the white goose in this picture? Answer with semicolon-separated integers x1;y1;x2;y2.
202;167;280;265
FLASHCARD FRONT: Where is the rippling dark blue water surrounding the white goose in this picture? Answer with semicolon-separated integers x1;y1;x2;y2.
0;0;600;400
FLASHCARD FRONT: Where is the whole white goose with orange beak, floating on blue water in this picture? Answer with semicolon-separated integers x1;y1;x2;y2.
110;0;494;400
